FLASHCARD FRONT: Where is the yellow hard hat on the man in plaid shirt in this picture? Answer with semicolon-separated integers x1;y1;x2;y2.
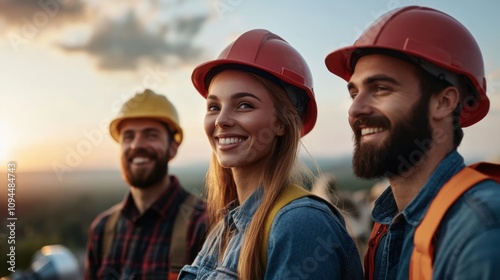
109;89;183;144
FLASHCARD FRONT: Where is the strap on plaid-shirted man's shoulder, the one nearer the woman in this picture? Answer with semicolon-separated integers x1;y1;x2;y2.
168;194;198;274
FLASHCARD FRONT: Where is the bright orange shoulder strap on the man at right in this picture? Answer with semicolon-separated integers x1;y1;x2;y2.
409;162;500;279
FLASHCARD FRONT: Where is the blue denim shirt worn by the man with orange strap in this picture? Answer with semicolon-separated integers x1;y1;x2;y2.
372;151;500;280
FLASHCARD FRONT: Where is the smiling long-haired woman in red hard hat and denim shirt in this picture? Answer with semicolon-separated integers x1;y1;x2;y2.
178;29;363;280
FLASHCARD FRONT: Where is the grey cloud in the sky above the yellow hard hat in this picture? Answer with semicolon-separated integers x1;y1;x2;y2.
61;11;207;71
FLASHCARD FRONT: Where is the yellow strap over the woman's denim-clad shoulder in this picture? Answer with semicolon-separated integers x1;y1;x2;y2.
260;185;339;269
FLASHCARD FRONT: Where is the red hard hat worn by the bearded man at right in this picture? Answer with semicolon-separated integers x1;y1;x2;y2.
325;6;490;127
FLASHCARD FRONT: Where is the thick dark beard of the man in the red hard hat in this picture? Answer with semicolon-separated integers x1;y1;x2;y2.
352;98;433;179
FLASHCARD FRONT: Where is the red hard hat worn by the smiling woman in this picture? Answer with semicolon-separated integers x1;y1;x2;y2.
191;29;317;136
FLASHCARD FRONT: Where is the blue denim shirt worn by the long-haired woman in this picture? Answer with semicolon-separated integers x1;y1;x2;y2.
178;188;363;280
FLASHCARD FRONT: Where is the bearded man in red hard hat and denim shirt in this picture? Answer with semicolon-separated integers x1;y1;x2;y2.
325;6;500;280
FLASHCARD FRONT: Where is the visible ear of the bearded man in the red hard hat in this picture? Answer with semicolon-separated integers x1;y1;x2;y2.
429;86;460;120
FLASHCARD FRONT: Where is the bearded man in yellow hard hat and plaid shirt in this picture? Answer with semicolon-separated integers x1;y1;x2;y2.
85;89;206;279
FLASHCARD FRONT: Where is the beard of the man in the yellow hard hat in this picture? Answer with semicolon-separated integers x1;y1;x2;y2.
121;148;168;189
